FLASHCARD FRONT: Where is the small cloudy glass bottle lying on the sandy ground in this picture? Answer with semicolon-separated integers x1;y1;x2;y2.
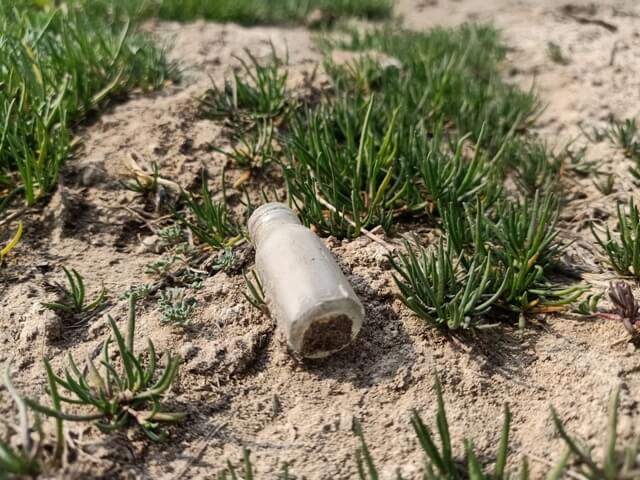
248;203;364;358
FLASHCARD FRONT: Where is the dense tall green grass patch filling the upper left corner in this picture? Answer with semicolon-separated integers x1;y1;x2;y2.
0;1;178;214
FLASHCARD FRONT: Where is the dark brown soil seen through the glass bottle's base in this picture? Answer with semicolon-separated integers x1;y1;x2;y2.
300;314;353;358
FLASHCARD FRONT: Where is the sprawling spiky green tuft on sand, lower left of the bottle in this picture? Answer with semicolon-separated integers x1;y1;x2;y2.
26;296;185;441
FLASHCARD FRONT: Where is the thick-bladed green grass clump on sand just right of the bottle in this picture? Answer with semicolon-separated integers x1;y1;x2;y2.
390;194;586;330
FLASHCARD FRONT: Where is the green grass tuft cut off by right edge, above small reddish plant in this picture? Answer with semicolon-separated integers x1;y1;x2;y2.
591;198;640;278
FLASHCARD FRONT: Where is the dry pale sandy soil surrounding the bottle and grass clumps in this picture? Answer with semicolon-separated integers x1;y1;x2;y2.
0;0;640;479
